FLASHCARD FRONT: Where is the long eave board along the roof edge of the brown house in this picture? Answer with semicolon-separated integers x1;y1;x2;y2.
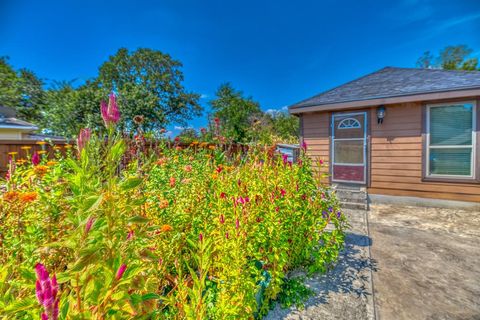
288;87;480;114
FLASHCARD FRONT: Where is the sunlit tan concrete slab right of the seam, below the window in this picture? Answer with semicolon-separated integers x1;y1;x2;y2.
369;205;480;320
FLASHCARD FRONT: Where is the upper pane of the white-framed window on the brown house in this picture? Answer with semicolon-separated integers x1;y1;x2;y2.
430;104;473;146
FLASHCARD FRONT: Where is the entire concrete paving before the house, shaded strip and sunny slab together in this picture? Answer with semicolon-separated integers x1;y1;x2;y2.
265;205;480;320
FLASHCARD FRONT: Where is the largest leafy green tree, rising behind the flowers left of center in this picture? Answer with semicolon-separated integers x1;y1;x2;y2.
93;48;202;131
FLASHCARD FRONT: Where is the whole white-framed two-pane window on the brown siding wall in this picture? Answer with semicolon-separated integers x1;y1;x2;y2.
426;102;477;179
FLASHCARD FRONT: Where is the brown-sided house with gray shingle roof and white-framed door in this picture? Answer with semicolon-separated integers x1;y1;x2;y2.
289;67;480;204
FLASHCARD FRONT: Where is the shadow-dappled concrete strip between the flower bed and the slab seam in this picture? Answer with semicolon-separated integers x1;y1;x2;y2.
265;211;375;320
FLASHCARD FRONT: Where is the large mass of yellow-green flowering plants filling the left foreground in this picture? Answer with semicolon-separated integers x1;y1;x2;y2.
0;96;346;319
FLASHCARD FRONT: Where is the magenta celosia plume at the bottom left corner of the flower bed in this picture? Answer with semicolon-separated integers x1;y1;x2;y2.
35;263;59;320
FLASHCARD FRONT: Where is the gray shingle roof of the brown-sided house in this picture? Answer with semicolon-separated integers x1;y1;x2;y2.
290;67;480;108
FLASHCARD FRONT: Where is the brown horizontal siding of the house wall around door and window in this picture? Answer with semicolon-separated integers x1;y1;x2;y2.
302;102;480;202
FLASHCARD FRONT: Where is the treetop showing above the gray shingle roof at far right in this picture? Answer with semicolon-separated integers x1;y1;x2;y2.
417;45;478;71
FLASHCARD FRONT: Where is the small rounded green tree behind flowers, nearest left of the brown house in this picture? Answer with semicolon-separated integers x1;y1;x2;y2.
210;83;263;143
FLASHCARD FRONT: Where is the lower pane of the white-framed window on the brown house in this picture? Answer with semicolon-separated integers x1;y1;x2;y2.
430;148;472;176
